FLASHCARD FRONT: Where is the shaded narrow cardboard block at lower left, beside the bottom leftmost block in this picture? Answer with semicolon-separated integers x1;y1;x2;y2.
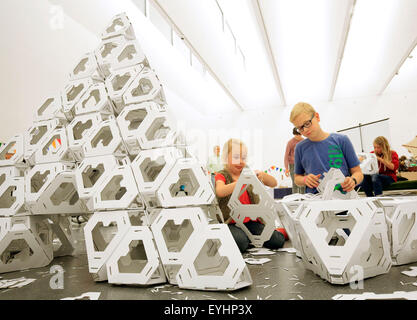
48;215;75;258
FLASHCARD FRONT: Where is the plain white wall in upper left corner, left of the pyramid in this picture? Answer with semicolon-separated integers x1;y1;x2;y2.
0;0;98;142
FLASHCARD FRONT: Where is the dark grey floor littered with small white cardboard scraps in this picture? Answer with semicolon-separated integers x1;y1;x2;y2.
0;221;417;300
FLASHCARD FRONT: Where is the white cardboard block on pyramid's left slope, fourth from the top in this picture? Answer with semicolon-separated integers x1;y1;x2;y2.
62;78;96;121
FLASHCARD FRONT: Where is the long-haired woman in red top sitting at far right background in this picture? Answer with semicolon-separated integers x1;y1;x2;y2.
362;136;399;197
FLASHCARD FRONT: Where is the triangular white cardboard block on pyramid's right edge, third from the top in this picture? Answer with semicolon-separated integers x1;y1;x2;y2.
123;67;166;105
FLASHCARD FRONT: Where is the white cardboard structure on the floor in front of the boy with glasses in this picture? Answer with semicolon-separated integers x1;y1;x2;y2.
276;170;417;284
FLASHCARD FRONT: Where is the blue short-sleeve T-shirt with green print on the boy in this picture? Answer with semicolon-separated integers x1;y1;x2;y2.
294;133;360;193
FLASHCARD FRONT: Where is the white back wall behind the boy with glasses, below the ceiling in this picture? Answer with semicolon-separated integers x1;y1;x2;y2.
196;92;417;169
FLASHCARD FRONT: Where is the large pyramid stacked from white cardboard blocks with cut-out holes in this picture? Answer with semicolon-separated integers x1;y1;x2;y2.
0;14;252;290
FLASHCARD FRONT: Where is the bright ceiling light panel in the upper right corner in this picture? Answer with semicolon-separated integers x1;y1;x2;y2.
334;0;417;99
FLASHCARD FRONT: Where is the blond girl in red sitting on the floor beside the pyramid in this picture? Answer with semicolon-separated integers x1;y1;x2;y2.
215;139;285;252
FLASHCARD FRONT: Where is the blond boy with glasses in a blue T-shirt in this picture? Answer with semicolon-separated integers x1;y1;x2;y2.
290;102;363;193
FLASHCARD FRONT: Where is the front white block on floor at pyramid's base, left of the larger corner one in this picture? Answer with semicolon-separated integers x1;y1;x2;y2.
106;226;166;285
